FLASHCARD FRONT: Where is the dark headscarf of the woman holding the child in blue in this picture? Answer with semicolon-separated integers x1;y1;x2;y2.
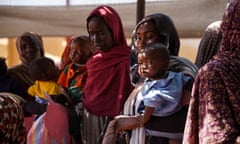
132;13;180;56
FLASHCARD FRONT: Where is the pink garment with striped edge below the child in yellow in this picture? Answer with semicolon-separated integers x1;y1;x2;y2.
27;98;71;144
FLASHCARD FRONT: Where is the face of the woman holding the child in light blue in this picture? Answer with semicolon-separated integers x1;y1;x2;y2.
135;21;166;51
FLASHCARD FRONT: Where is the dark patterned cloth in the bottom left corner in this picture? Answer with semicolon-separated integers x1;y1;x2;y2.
0;93;26;144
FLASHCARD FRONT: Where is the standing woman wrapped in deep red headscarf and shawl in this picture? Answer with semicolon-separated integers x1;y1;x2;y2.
83;6;133;144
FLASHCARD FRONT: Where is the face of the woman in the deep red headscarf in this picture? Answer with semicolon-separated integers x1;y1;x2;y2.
88;16;113;52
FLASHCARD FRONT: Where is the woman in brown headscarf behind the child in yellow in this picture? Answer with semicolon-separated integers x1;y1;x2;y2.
8;32;44;100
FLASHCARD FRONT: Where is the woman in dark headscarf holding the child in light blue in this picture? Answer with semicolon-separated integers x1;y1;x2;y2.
112;13;198;144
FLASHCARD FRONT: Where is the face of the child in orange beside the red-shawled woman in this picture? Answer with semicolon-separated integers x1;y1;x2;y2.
69;42;90;64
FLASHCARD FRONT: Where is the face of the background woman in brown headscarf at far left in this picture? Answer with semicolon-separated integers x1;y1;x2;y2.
20;37;41;64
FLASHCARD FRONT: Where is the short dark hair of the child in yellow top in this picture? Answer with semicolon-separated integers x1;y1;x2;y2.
30;57;57;81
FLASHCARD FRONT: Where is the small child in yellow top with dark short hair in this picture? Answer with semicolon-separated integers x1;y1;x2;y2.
28;57;62;104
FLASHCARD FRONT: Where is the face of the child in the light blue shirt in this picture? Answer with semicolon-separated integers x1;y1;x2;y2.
138;52;166;80
